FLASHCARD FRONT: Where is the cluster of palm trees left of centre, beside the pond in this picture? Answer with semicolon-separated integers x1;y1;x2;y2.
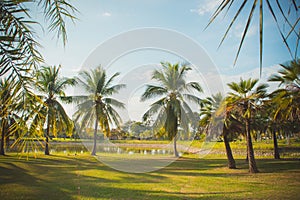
0;66;124;155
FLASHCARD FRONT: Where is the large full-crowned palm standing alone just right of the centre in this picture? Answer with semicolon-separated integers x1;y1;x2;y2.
141;62;202;157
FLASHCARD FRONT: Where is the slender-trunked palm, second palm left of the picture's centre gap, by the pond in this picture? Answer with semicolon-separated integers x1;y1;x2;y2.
74;66;125;155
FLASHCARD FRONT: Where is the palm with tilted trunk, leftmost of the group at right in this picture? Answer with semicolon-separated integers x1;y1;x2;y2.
200;93;236;169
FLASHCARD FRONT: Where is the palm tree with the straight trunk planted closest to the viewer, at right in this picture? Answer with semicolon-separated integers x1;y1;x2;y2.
227;78;268;173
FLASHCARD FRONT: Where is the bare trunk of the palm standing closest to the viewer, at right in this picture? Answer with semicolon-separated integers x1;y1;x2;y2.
246;119;258;173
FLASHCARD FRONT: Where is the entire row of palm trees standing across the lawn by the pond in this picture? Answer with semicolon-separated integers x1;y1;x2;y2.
0;60;300;173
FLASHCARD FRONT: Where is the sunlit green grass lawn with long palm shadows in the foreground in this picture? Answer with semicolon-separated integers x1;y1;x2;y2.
0;153;300;199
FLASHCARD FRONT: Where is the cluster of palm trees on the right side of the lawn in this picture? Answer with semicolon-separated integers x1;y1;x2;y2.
200;60;300;173
